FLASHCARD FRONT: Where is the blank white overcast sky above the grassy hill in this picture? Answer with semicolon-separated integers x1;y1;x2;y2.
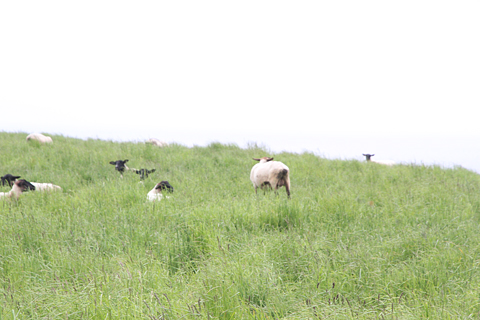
0;0;480;172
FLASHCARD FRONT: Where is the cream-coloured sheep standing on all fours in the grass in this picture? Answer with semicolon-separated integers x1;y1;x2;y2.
250;157;290;198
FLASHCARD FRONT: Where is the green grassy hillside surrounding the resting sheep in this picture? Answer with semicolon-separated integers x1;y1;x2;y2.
0;132;480;319
